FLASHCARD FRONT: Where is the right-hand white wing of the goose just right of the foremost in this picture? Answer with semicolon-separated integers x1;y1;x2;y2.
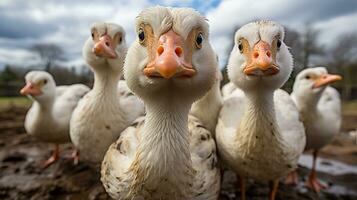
274;89;306;159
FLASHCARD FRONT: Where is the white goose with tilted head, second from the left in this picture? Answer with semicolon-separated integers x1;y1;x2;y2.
70;22;144;166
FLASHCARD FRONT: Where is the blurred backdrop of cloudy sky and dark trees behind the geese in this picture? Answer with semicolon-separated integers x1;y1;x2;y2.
0;0;357;100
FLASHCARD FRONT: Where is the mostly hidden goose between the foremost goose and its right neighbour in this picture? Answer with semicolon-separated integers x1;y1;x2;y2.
190;66;223;136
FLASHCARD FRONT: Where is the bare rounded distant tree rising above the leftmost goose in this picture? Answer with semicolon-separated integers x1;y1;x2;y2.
30;43;65;72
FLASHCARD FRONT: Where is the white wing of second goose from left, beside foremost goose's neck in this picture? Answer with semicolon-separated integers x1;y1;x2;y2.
118;80;145;122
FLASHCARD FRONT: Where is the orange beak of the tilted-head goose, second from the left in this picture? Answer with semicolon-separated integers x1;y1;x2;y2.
93;34;118;59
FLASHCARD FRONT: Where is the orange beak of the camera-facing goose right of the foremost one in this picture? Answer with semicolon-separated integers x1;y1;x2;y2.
243;41;280;76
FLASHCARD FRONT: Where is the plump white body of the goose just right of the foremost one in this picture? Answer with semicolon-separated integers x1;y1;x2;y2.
216;88;305;181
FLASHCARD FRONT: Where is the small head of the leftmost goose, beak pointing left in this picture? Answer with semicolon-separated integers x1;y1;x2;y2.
20;71;56;102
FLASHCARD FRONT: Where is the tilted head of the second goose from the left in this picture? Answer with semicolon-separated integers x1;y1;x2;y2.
82;22;127;72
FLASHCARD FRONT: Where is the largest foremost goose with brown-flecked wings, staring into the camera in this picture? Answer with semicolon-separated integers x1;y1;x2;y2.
101;6;220;200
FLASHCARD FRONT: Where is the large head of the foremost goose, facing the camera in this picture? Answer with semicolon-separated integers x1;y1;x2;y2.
124;6;217;103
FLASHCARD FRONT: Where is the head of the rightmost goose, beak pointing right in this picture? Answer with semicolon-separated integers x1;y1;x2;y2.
293;67;342;103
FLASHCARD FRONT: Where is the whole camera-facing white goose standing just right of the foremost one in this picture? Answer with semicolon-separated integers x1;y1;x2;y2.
216;20;305;200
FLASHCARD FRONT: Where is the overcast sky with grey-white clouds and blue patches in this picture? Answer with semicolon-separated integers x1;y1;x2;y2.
0;0;357;67
